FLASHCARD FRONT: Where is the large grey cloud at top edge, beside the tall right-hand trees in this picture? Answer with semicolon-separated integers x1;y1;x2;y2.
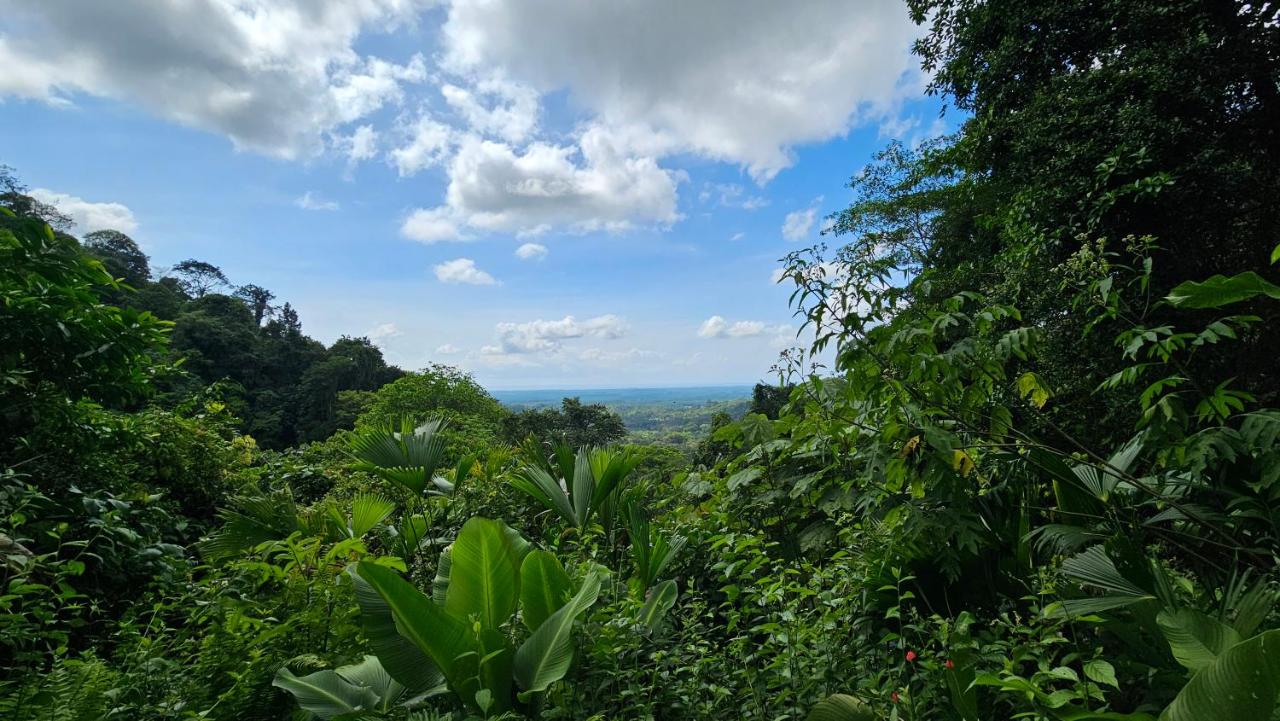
444;0;916;181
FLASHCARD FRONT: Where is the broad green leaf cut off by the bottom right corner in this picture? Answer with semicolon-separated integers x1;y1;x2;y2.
1160;630;1280;721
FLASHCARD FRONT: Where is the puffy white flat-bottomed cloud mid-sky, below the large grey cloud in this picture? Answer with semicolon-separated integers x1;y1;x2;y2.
403;129;682;242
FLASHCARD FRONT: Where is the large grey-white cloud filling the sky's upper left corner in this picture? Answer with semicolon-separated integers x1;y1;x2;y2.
0;0;430;159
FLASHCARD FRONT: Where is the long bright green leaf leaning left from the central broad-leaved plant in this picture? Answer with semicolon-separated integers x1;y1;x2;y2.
356;561;477;690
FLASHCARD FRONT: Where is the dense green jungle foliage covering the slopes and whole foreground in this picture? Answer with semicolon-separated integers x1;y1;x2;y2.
0;0;1280;721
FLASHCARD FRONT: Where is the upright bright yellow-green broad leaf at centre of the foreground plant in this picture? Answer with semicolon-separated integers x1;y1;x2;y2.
444;516;520;630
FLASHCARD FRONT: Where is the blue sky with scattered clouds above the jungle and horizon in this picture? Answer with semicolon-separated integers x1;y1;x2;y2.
0;0;954;389
